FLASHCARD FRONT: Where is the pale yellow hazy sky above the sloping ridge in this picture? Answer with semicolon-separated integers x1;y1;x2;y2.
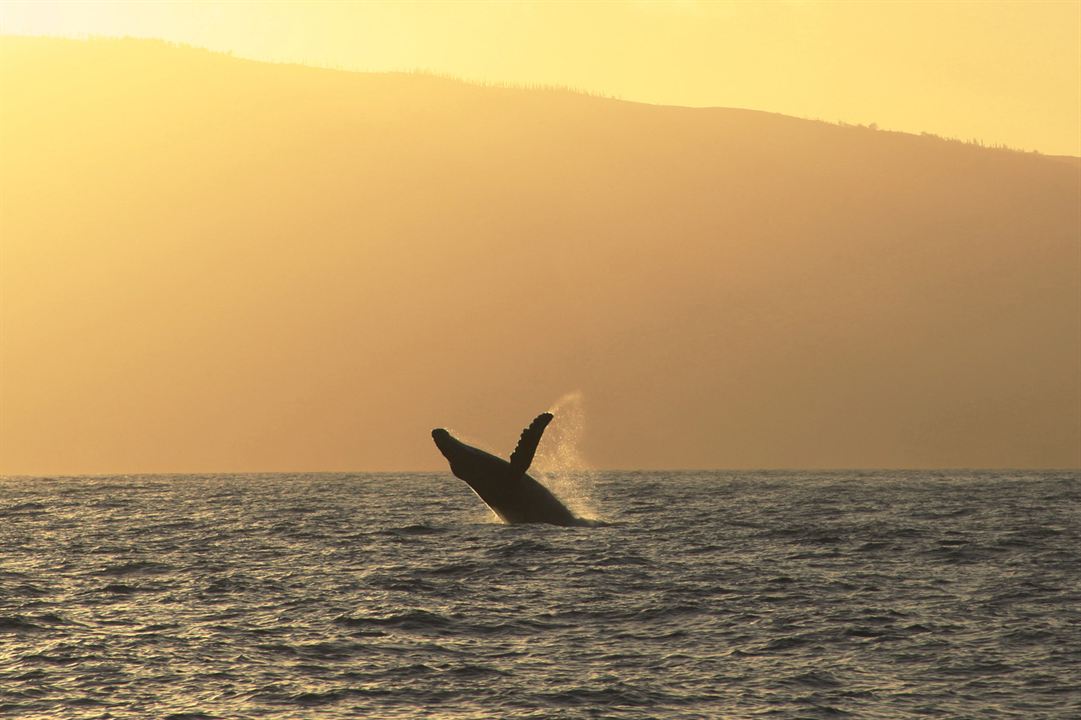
0;0;1081;155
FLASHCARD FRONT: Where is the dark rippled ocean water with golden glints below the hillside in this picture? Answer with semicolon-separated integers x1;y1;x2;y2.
0;471;1081;719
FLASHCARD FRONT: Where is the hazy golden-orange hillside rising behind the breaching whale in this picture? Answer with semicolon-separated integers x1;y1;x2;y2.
0;38;1081;474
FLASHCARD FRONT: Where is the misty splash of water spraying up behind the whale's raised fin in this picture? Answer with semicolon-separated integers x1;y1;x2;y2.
533;390;599;520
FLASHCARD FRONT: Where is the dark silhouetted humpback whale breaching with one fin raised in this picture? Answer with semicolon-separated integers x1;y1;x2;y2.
431;413;599;525
